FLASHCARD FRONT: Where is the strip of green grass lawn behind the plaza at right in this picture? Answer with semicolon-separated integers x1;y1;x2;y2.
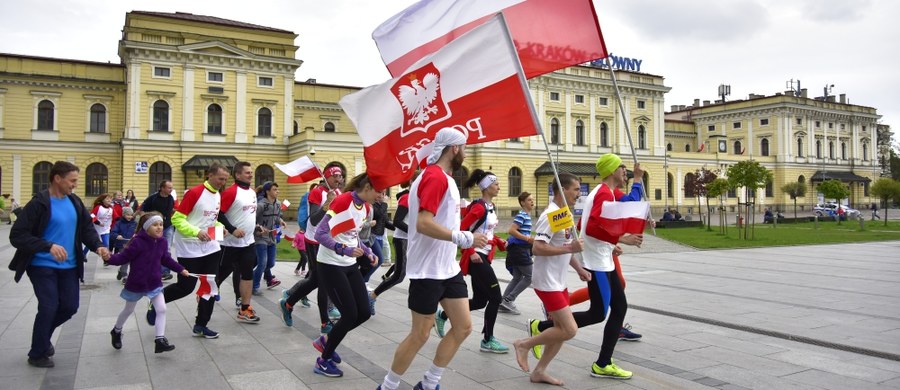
656;220;900;249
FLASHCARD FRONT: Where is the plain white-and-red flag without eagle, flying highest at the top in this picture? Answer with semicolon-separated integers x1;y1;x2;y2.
372;0;607;79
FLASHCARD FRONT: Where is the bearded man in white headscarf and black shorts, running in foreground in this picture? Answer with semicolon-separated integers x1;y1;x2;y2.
380;128;487;390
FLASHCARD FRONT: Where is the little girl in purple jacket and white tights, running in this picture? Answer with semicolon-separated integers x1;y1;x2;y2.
109;211;188;353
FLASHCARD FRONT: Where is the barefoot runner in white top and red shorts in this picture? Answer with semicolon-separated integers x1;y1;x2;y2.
513;173;591;386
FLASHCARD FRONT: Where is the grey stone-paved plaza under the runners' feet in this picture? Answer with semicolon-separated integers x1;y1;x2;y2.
0;225;900;390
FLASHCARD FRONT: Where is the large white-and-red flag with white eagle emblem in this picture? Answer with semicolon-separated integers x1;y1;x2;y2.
340;16;538;189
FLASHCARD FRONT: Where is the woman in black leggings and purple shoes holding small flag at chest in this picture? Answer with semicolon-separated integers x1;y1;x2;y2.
313;173;379;377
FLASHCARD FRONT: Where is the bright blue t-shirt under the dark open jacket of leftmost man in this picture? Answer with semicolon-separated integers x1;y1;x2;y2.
31;196;81;269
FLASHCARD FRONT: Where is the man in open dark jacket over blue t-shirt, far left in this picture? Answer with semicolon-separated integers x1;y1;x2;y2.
9;161;109;367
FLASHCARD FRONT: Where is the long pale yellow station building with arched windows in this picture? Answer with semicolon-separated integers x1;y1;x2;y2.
0;11;878;221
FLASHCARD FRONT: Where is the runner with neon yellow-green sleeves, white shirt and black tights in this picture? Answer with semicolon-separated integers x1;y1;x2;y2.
147;163;228;339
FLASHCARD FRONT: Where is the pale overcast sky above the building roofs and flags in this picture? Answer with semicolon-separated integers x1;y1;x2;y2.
0;0;900;143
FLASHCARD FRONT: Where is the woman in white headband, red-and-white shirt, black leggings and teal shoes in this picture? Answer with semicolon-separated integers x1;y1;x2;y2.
434;169;509;353
